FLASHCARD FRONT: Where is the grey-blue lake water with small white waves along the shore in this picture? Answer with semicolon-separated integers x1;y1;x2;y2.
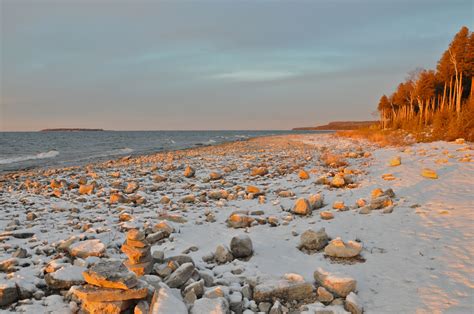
0;131;324;172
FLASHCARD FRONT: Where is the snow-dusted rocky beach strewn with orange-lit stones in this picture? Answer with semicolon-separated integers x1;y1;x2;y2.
0;134;474;314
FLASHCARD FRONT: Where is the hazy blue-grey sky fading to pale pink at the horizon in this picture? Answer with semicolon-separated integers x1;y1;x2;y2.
0;0;474;131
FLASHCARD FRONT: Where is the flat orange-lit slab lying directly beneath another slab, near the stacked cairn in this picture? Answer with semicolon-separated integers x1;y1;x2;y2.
70;284;148;302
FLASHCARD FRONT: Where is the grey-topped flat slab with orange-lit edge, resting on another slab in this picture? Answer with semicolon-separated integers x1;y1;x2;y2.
83;260;138;290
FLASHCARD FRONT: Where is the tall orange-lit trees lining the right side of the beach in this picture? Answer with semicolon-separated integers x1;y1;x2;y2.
378;26;474;139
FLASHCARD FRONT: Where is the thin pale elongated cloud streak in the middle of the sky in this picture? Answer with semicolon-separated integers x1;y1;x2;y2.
211;70;297;82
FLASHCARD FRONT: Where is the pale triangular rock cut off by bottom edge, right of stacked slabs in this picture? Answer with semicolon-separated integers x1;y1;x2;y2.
149;283;188;314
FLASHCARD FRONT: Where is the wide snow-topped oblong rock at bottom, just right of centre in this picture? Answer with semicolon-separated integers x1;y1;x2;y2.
253;279;313;302
